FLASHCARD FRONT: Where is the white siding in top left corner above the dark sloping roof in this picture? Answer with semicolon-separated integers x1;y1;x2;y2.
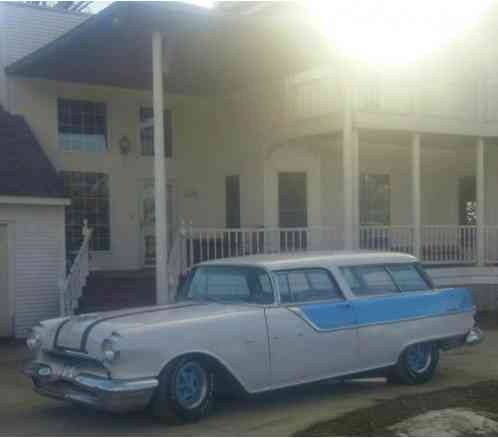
0;2;89;107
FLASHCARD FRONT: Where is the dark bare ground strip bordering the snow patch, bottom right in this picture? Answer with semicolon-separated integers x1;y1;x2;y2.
296;380;498;436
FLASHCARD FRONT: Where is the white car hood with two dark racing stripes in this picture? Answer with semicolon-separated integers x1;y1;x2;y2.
53;302;242;353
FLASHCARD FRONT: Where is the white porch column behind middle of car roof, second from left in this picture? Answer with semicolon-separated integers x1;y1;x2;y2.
342;74;360;250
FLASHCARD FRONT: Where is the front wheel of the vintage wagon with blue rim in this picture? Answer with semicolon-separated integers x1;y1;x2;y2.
153;357;215;421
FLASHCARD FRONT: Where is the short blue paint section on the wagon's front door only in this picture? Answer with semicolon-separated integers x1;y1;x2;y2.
299;302;356;330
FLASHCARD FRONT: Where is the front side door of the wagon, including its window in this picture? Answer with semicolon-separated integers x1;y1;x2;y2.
266;268;357;387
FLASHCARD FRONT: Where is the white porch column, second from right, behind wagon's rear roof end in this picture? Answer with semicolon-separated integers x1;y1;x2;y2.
412;133;422;258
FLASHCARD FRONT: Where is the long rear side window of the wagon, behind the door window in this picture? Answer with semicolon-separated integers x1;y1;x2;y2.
341;263;432;296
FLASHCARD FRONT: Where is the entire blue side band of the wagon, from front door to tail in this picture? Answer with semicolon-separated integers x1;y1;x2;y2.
297;288;474;330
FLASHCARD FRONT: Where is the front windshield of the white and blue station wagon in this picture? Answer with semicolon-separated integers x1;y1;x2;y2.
178;266;274;304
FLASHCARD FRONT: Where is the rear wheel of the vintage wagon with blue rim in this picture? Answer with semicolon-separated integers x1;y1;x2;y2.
388;342;439;385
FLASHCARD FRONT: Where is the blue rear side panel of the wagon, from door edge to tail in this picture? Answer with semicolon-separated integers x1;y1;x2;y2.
353;288;474;325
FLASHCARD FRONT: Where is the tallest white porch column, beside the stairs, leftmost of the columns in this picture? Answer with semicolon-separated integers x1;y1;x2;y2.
152;32;169;305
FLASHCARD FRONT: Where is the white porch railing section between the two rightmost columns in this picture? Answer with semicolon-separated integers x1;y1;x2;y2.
421;225;477;264
